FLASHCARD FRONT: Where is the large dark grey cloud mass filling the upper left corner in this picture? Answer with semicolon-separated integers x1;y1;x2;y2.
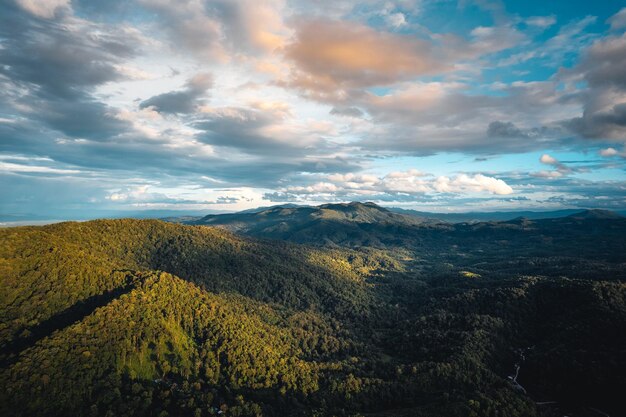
0;5;141;140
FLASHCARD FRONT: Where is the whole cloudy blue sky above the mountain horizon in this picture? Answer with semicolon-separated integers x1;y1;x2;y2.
0;0;626;220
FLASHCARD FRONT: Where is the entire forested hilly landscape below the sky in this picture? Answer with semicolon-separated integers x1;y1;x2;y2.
0;204;626;417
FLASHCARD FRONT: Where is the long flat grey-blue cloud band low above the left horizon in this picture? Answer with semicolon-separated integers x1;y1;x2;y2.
0;112;361;187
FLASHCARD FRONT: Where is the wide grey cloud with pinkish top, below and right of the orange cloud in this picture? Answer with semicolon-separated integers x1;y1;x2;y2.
353;76;580;154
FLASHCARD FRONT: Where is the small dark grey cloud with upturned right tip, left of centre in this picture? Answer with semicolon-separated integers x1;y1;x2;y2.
139;73;213;114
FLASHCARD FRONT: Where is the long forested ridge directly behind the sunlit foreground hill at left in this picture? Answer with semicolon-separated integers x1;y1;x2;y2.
0;219;391;340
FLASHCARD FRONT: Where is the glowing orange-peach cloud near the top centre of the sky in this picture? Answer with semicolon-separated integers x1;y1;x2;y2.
285;19;447;92
